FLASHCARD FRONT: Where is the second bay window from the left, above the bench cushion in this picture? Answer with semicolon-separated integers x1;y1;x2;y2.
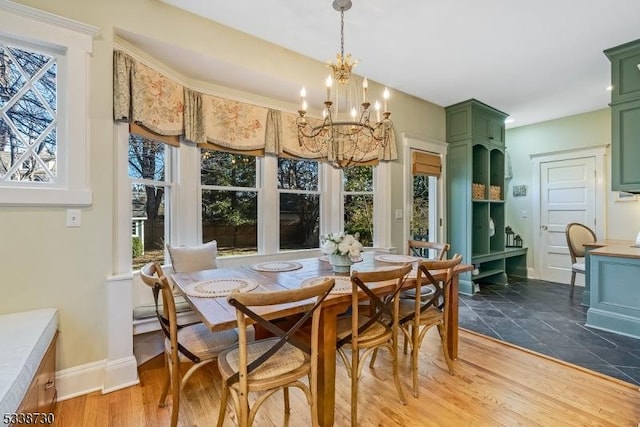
201;150;258;256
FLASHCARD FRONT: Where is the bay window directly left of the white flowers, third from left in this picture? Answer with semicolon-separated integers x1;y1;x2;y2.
278;158;320;249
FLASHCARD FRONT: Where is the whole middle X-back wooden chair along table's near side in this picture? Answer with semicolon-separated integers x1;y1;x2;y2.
337;264;411;426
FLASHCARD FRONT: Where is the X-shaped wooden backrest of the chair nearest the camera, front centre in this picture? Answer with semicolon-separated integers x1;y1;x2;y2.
227;279;335;391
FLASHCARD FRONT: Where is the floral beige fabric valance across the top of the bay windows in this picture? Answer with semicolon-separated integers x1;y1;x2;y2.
113;51;398;164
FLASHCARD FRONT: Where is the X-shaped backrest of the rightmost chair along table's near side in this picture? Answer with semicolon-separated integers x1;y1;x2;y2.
410;254;462;322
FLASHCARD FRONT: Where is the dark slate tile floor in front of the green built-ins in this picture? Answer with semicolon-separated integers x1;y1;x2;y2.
460;279;640;385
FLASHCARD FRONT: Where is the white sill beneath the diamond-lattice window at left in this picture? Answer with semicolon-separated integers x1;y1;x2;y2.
0;187;92;206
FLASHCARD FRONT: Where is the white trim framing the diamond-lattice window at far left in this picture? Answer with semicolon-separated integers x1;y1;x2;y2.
0;0;98;206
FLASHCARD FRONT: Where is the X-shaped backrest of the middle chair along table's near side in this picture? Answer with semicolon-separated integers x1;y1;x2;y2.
338;264;412;347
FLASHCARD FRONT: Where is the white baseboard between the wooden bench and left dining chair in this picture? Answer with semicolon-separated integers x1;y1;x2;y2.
56;356;139;401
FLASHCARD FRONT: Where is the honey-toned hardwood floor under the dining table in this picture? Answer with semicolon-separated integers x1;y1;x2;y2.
54;330;640;427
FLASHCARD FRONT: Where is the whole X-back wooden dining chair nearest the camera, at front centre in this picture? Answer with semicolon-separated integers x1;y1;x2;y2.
218;279;335;427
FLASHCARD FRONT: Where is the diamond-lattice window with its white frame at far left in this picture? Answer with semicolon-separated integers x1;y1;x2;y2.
0;3;97;205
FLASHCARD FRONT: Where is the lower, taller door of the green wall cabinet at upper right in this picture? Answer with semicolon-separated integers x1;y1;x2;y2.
611;100;640;192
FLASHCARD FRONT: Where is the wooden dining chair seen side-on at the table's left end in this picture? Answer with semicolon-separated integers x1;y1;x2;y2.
140;262;238;427
